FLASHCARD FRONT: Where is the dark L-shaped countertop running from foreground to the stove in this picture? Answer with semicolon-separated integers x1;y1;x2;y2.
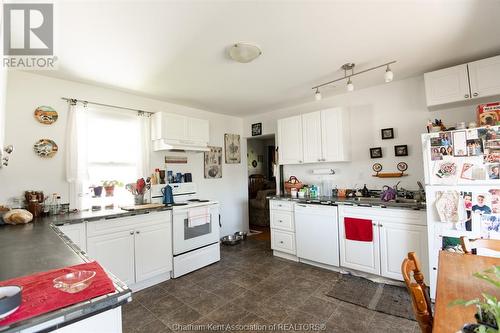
0;207;171;333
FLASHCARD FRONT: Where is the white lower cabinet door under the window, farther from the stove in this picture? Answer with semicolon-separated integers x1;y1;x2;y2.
87;230;135;284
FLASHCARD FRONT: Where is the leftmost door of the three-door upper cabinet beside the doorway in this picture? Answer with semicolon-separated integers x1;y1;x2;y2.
278;116;304;164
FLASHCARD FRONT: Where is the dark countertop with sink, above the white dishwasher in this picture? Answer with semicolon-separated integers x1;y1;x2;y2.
267;195;426;210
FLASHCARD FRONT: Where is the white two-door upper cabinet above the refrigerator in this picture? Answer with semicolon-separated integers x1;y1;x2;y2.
424;56;500;109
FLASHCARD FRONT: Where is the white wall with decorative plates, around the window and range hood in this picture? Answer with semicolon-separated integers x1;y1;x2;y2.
0;71;248;234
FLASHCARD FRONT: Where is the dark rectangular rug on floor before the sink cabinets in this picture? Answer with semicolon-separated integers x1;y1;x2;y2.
326;275;415;320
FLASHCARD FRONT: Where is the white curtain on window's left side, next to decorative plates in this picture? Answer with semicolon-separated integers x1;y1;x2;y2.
66;101;89;210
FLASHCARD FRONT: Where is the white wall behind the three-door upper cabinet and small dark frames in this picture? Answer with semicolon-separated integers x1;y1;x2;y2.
244;76;475;189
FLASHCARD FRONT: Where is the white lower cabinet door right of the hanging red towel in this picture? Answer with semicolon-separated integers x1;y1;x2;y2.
379;221;428;281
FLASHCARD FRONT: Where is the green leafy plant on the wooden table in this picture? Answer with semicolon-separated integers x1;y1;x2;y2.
451;266;500;333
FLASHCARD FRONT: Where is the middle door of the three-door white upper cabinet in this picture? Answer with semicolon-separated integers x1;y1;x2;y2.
302;111;322;163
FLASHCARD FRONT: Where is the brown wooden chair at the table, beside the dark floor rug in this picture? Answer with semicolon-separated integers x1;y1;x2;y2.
401;252;433;333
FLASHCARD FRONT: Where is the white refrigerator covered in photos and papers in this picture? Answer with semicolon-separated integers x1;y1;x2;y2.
422;126;500;299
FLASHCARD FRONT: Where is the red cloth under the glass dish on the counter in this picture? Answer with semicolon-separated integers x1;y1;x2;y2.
0;261;115;327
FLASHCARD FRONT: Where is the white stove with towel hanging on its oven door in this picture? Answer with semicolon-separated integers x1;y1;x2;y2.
151;183;221;278
